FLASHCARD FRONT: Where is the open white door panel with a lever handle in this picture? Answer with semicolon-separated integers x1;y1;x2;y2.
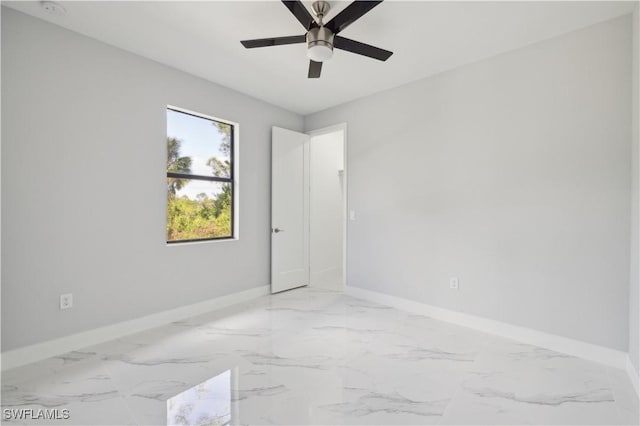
271;127;309;293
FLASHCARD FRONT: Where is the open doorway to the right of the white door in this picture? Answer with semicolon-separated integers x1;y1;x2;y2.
308;124;346;290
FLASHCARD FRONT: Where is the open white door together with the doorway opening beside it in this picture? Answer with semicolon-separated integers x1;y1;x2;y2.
271;124;347;293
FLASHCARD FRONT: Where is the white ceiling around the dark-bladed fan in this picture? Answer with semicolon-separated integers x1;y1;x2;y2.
3;0;634;114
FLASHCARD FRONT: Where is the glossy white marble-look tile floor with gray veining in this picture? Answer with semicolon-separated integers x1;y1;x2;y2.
2;289;638;425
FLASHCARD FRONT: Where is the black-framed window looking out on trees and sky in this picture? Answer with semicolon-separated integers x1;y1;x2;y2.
167;107;236;243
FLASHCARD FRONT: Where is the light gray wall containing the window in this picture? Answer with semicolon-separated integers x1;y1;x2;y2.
2;8;303;350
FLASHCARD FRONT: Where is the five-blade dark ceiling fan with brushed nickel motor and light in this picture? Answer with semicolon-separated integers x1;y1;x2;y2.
240;0;393;78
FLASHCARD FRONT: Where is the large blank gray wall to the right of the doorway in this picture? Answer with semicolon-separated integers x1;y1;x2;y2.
305;15;631;351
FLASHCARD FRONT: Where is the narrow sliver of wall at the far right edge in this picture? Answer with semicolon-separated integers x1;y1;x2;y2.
629;4;640;372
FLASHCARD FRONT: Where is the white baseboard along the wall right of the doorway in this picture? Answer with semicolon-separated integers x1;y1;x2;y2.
345;286;637;370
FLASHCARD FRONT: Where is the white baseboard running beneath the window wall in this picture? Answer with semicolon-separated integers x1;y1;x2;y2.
1;285;271;371
